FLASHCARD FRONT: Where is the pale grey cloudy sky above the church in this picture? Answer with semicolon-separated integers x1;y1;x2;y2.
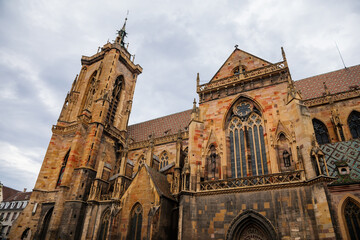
0;0;360;190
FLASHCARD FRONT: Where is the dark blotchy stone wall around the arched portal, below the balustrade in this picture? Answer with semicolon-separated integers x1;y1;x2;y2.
180;185;335;239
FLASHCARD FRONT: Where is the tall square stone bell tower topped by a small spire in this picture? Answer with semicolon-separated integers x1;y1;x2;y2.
10;19;142;239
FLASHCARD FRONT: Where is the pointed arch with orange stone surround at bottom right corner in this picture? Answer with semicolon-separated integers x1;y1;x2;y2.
338;194;360;239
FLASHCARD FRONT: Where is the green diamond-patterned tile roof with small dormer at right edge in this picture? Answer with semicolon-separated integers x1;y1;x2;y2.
320;139;360;180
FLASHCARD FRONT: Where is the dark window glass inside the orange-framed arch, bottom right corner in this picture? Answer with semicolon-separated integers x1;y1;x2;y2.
344;198;360;239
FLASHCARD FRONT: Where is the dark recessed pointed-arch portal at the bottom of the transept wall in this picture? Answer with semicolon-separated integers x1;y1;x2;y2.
226;210;277;240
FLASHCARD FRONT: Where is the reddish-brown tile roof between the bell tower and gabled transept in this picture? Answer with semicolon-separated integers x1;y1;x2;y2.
128;109;192;142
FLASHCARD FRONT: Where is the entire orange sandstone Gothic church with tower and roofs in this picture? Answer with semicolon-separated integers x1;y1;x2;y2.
10;21;360;240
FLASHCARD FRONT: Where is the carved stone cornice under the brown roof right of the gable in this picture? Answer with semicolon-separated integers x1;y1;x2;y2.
303;89;360;107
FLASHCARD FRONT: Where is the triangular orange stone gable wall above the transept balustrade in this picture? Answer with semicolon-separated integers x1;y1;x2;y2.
210;49;271;82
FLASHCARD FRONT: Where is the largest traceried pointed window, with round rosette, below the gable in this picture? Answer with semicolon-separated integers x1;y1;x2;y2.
228;101;268;178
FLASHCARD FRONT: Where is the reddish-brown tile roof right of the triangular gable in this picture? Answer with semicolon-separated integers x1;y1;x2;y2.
295;65;360;100
